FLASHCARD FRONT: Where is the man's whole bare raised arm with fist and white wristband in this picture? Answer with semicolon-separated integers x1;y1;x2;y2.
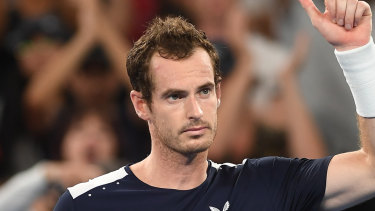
300;0;375;210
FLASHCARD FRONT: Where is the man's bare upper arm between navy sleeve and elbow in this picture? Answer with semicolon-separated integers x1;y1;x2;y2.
322;150;375;210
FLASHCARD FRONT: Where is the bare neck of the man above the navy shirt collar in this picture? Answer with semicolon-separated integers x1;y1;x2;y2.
131;143;208;190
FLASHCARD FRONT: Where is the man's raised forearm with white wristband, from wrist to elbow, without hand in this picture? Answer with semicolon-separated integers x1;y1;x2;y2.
335;39;375;159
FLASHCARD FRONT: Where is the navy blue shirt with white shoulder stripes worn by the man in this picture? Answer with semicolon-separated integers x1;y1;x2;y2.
54;157;332;211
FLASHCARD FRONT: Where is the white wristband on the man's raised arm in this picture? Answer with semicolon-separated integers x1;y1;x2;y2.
335;37;375;117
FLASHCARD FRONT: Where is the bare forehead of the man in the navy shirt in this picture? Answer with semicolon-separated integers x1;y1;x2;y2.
150;48;214;91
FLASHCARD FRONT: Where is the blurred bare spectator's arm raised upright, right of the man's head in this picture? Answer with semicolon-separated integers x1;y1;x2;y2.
280;32;327;159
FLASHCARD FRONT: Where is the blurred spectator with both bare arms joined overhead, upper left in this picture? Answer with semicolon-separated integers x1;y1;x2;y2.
20;1;148;163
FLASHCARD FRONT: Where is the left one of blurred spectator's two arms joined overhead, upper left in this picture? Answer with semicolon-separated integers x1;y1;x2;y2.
24;1;96;131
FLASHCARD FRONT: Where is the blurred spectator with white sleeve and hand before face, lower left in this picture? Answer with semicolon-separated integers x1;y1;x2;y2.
0;109;126;210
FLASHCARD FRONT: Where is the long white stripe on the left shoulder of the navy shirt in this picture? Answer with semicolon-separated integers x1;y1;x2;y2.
68;167;128;199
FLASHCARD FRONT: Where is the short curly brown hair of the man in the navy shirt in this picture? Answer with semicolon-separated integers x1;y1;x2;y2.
126;17;221;104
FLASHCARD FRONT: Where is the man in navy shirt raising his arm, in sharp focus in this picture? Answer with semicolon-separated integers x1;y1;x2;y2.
55;0;375;211
